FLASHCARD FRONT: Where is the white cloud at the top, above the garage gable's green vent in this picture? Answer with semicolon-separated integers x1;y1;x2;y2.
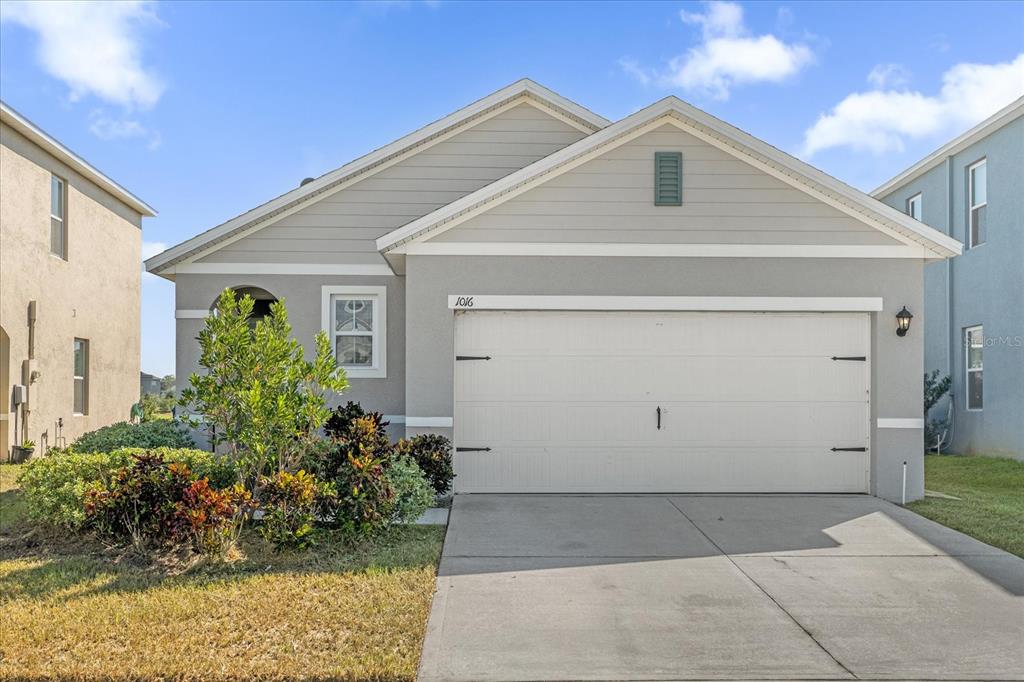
647;1;814;99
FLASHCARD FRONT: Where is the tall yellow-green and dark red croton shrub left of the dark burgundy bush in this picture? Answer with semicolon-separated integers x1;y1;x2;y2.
304;415;394;538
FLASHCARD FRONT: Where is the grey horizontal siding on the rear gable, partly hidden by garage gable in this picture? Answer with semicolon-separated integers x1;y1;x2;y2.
199;103;585;264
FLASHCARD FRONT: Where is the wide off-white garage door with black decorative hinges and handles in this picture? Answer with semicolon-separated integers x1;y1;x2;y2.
455;311;870;493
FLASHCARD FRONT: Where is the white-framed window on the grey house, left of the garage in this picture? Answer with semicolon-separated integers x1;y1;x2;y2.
324;287;387;378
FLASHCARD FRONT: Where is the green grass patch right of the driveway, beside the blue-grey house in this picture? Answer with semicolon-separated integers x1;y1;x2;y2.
907;455;1024;557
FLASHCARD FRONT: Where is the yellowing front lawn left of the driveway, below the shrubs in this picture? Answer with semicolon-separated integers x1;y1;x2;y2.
0;458;443;681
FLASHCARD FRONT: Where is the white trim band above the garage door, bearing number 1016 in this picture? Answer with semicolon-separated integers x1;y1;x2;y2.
449;294;882;312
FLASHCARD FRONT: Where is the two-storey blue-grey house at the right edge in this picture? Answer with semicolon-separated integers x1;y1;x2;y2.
871;97;1024;459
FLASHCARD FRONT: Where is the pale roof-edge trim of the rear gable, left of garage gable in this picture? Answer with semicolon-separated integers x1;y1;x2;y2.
145;78;610;273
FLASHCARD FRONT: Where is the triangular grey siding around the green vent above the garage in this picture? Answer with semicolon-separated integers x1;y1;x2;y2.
431;124;899;246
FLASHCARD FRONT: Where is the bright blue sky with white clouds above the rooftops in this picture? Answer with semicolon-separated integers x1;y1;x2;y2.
0;0;1024;374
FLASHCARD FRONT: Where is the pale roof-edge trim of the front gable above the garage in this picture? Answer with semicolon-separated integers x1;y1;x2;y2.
377;96;962;257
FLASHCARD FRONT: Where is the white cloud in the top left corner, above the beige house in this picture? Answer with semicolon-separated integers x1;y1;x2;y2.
0;0;164;109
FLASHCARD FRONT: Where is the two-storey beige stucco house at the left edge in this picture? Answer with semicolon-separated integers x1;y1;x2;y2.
0;102;155;459
